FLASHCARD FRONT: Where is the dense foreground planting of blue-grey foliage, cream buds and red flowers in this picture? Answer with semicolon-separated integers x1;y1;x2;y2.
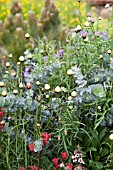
0;0;113;170
